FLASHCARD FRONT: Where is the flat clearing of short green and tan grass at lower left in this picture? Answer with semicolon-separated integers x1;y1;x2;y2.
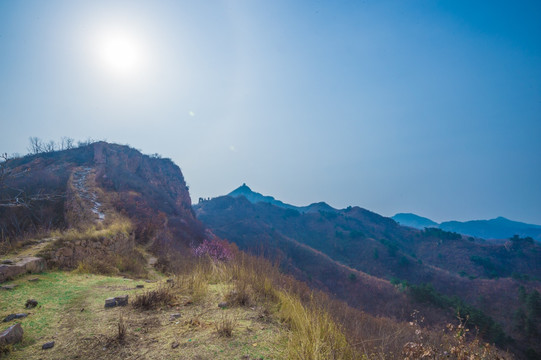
0;272;287;359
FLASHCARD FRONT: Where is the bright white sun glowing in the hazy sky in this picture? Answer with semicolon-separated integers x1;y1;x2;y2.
95;29;146;77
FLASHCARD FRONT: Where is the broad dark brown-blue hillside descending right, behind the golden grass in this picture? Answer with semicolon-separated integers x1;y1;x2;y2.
195;187;541;356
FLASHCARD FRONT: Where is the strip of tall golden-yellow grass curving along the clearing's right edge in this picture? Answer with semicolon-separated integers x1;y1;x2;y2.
177;252;355;360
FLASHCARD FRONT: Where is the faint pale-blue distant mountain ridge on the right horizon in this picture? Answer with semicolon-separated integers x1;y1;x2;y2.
392;213;541;241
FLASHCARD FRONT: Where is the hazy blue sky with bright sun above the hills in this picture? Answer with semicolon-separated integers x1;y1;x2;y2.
0;0;541;223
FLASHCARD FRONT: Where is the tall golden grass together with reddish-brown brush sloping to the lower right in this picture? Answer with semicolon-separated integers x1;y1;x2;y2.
200;252;510;359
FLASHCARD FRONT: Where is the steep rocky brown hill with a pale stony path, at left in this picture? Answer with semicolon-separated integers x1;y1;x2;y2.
0;142;205;255
